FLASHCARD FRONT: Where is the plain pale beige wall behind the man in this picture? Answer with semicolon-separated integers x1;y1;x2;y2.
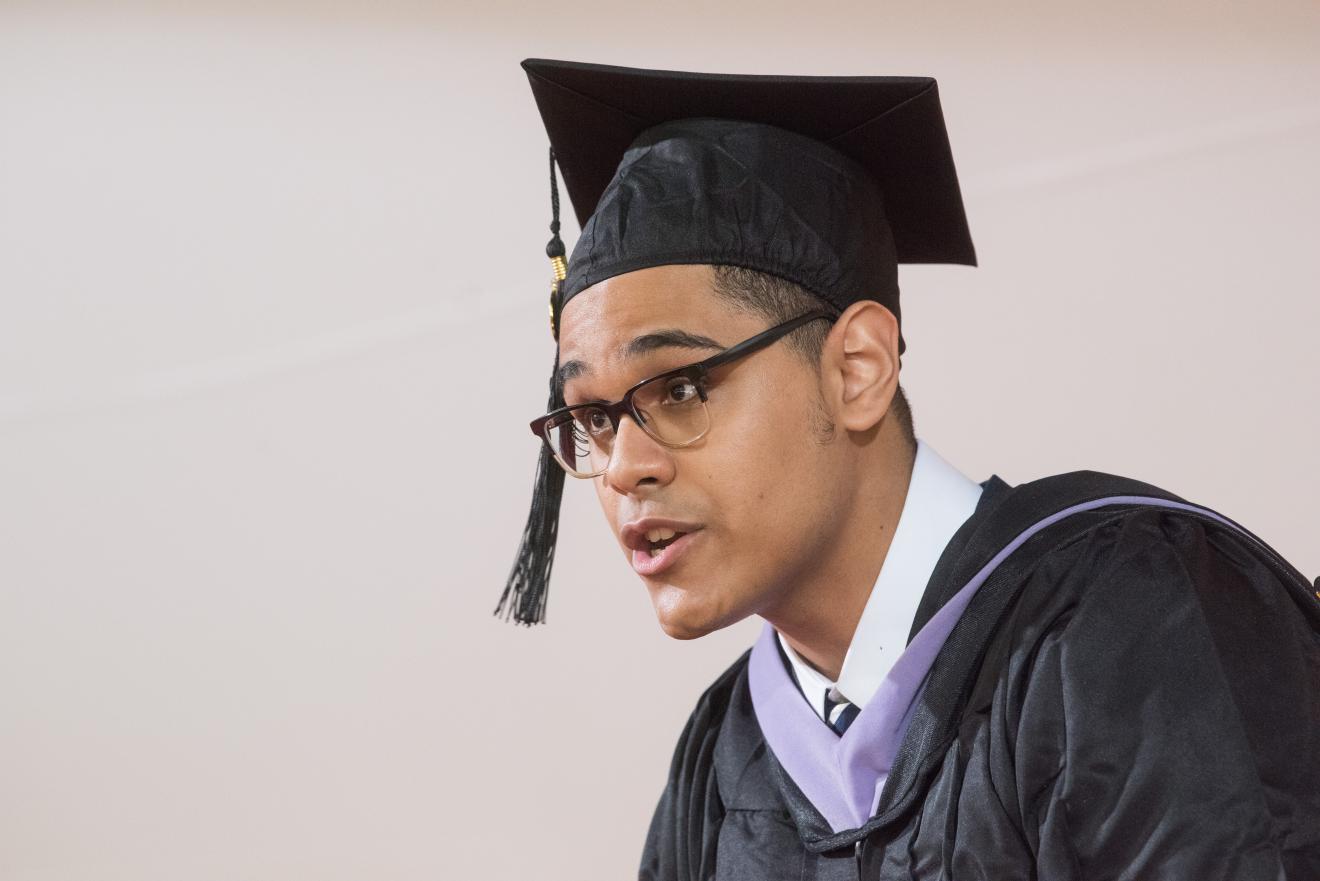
0;0;1320;881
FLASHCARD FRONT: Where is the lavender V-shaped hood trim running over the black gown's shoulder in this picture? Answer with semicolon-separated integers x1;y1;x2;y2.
747;495;1241;832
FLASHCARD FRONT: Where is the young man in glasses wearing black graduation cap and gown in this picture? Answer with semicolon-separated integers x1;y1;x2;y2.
498;61;1320;881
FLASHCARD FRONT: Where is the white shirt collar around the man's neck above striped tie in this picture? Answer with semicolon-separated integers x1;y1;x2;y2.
779;437;982;719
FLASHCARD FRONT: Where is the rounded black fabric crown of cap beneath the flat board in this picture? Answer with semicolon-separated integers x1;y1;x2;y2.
560;118;902;351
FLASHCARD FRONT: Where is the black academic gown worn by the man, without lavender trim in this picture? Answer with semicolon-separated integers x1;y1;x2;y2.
640;472;1320;881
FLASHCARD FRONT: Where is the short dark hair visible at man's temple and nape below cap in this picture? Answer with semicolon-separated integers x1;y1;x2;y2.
713;264;916;452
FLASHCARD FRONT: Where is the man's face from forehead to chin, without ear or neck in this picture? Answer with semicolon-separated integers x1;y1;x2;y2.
560;265;847;639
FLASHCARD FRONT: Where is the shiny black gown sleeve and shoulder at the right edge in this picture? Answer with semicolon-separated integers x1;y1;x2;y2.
992;509;1320;880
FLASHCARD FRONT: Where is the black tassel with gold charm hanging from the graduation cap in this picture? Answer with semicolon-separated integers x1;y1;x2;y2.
495;147;566;625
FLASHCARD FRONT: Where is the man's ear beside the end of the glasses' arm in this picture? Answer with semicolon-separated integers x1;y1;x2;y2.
821;300;899;432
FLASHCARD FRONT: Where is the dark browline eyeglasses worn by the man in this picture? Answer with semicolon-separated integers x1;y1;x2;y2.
531;310;834;478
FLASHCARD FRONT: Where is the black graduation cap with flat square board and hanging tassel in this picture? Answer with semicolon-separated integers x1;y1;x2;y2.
495;58;975;623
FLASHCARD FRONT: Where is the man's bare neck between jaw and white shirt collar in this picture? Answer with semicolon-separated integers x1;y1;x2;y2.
760;433;915;680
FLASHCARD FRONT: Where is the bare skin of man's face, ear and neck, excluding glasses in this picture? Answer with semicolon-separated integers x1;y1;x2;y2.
560;264;911;666
